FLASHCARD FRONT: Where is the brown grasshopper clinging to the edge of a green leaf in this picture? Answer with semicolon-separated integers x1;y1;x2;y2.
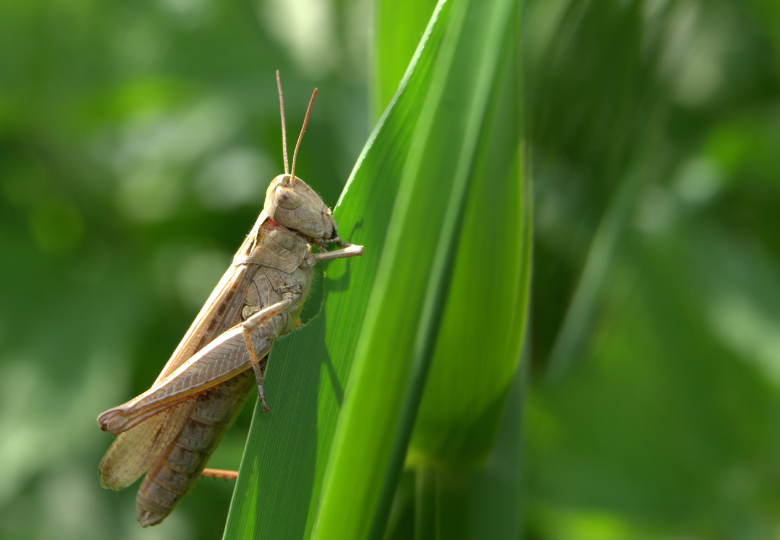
98;71;363;527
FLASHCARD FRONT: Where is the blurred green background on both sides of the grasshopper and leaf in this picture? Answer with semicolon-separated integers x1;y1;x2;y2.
0;0;780;540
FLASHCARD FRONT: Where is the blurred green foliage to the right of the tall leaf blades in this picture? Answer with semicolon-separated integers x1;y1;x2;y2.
524;0;780;540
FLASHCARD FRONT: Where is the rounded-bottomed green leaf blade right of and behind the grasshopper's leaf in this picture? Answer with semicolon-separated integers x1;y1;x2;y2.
408;0;531;473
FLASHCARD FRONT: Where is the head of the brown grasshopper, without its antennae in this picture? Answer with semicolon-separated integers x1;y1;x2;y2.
263;174;338;241
